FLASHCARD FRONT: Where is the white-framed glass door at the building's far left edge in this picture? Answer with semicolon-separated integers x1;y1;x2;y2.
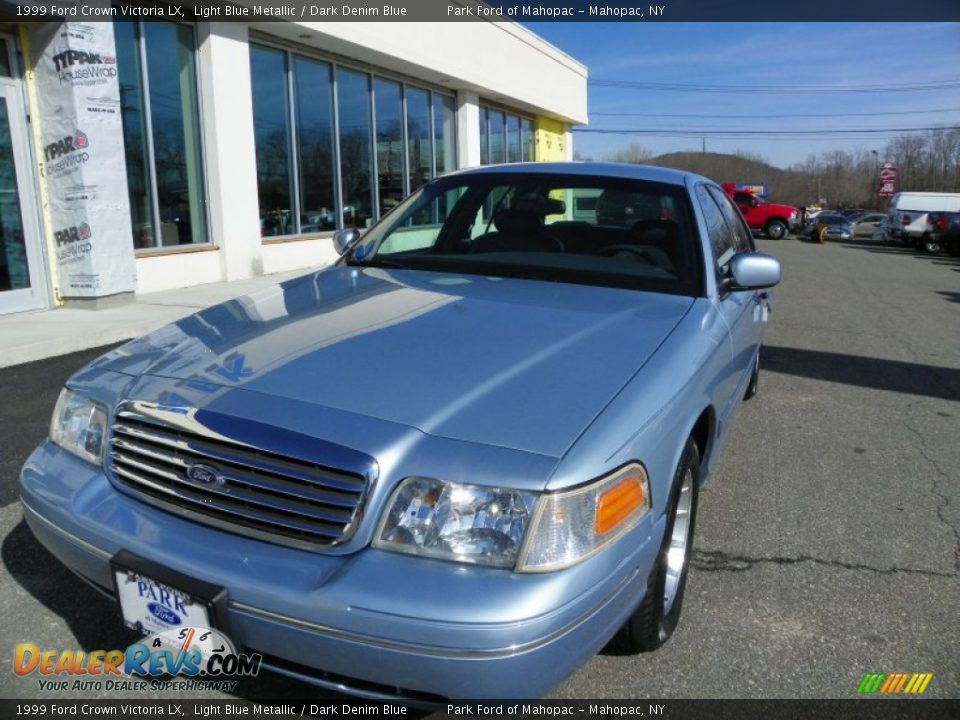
0;35;48;315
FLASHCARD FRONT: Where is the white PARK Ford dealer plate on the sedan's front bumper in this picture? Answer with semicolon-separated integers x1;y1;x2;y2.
114;568;211;634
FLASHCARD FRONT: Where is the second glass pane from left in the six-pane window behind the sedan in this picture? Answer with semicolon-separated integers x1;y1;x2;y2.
293;56;337;233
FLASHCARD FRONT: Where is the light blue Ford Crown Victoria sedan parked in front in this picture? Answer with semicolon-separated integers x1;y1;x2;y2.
21;163;780;702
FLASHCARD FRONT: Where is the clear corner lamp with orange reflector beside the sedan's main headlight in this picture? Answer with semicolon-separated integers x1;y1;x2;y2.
517;463;650;572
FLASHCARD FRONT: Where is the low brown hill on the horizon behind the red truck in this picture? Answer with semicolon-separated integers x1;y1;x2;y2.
646;152;816;205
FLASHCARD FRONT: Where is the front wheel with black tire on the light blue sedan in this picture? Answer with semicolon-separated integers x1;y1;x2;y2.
611;438;700;653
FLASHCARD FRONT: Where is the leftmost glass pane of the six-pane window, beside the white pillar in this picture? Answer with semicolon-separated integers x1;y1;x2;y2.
250;46;293;236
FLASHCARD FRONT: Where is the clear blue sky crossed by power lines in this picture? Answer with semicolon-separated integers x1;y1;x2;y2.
526;22;960;167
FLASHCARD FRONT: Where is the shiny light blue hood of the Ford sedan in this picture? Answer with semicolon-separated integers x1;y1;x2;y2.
94;267;693;457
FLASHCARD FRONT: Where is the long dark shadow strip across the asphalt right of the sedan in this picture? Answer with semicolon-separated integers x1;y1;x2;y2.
760;346;960;401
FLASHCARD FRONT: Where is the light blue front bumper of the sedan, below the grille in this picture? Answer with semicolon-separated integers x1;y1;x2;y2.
21;442;663;701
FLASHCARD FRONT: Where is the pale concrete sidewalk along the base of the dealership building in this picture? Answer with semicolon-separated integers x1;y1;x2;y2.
0;269;311;367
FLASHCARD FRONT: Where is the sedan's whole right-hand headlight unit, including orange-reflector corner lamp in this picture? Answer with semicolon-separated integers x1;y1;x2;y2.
373;463;650;572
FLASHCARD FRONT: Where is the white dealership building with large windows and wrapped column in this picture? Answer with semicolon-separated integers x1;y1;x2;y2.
0;11;587;314
